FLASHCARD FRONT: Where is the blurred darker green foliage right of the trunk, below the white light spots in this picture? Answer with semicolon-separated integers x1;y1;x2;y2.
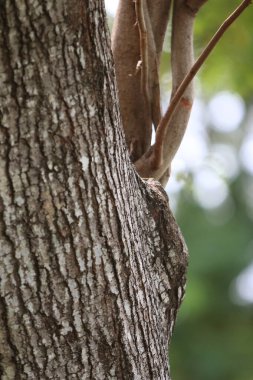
170;180;253;380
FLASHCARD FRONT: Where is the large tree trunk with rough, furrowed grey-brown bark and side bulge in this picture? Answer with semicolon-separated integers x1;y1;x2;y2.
0;0;187;380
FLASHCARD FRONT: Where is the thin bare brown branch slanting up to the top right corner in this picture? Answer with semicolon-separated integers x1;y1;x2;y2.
152;0;252;168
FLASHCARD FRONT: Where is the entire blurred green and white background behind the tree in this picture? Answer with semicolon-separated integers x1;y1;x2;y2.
105;0;253;380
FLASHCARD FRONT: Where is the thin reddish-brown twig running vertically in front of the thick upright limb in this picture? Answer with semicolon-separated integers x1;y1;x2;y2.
135;0;149;101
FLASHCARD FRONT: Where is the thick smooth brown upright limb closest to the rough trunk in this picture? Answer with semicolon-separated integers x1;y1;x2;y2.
112;0;170;162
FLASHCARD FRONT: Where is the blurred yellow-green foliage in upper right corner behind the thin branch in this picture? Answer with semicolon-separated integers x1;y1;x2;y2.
195;0;253;101
